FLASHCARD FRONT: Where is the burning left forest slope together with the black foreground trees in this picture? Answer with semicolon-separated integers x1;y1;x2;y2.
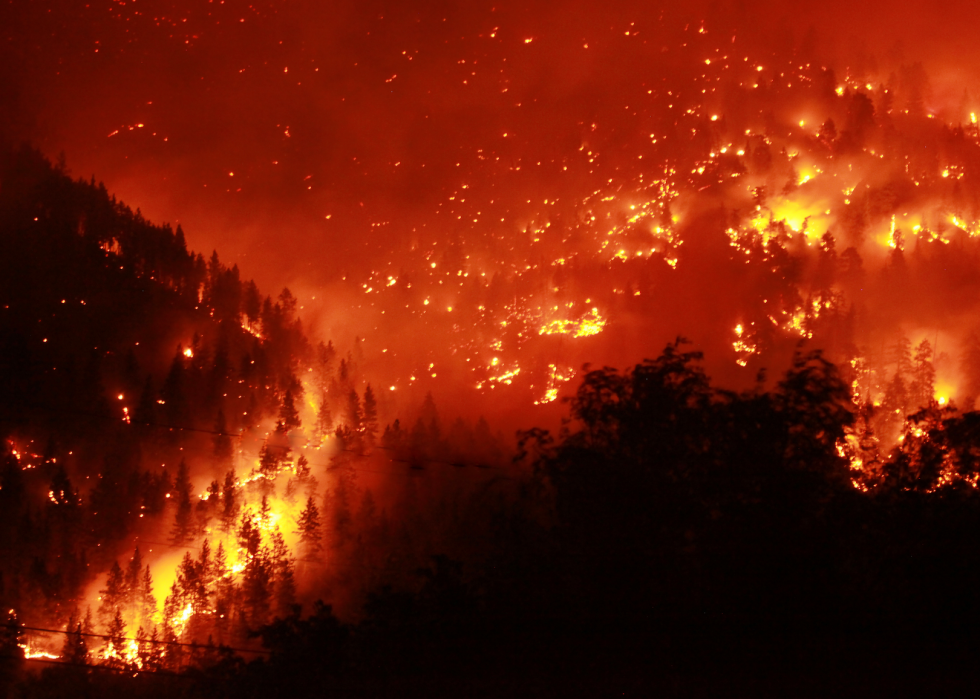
0;147;980;697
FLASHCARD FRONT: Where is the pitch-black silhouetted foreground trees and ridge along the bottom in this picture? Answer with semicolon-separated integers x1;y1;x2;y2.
7;344;980;697
